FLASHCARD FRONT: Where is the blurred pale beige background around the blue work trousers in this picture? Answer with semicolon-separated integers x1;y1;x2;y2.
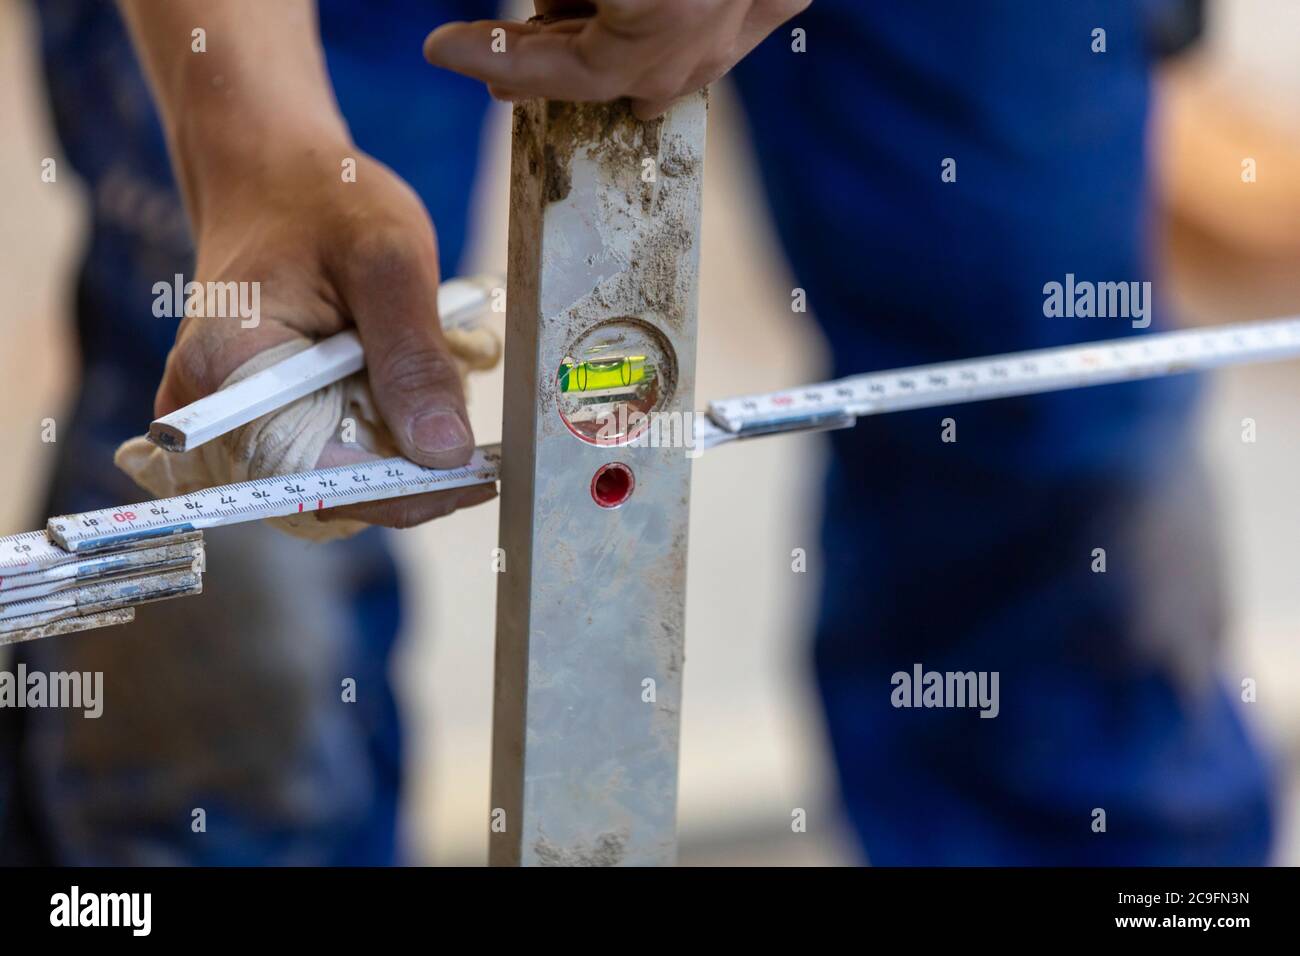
0;0;1300;864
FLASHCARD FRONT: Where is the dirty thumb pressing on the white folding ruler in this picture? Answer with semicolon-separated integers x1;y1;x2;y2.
342;233;475;468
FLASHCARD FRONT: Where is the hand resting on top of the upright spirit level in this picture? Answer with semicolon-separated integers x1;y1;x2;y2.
424;0;810;120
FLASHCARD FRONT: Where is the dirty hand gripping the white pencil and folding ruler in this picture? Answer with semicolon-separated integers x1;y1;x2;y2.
155;140;494;527
